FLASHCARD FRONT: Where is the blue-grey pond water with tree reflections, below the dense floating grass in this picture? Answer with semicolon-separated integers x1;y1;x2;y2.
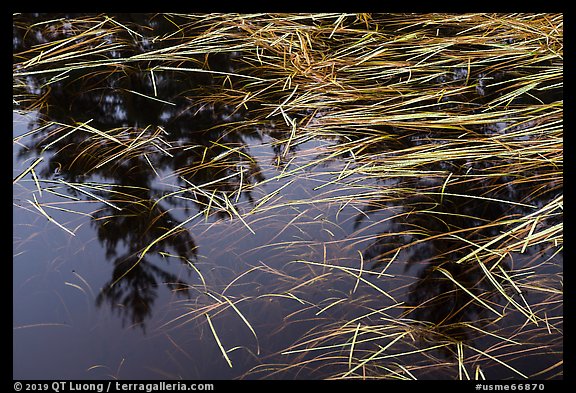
13;15;562;379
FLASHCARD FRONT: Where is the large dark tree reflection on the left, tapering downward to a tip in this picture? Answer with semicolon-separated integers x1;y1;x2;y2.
13;14;264;329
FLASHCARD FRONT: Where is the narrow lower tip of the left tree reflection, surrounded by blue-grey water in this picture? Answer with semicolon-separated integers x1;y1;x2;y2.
92;182;196;329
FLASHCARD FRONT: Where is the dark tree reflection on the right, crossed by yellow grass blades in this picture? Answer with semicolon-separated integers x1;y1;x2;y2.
356;138;555;356
